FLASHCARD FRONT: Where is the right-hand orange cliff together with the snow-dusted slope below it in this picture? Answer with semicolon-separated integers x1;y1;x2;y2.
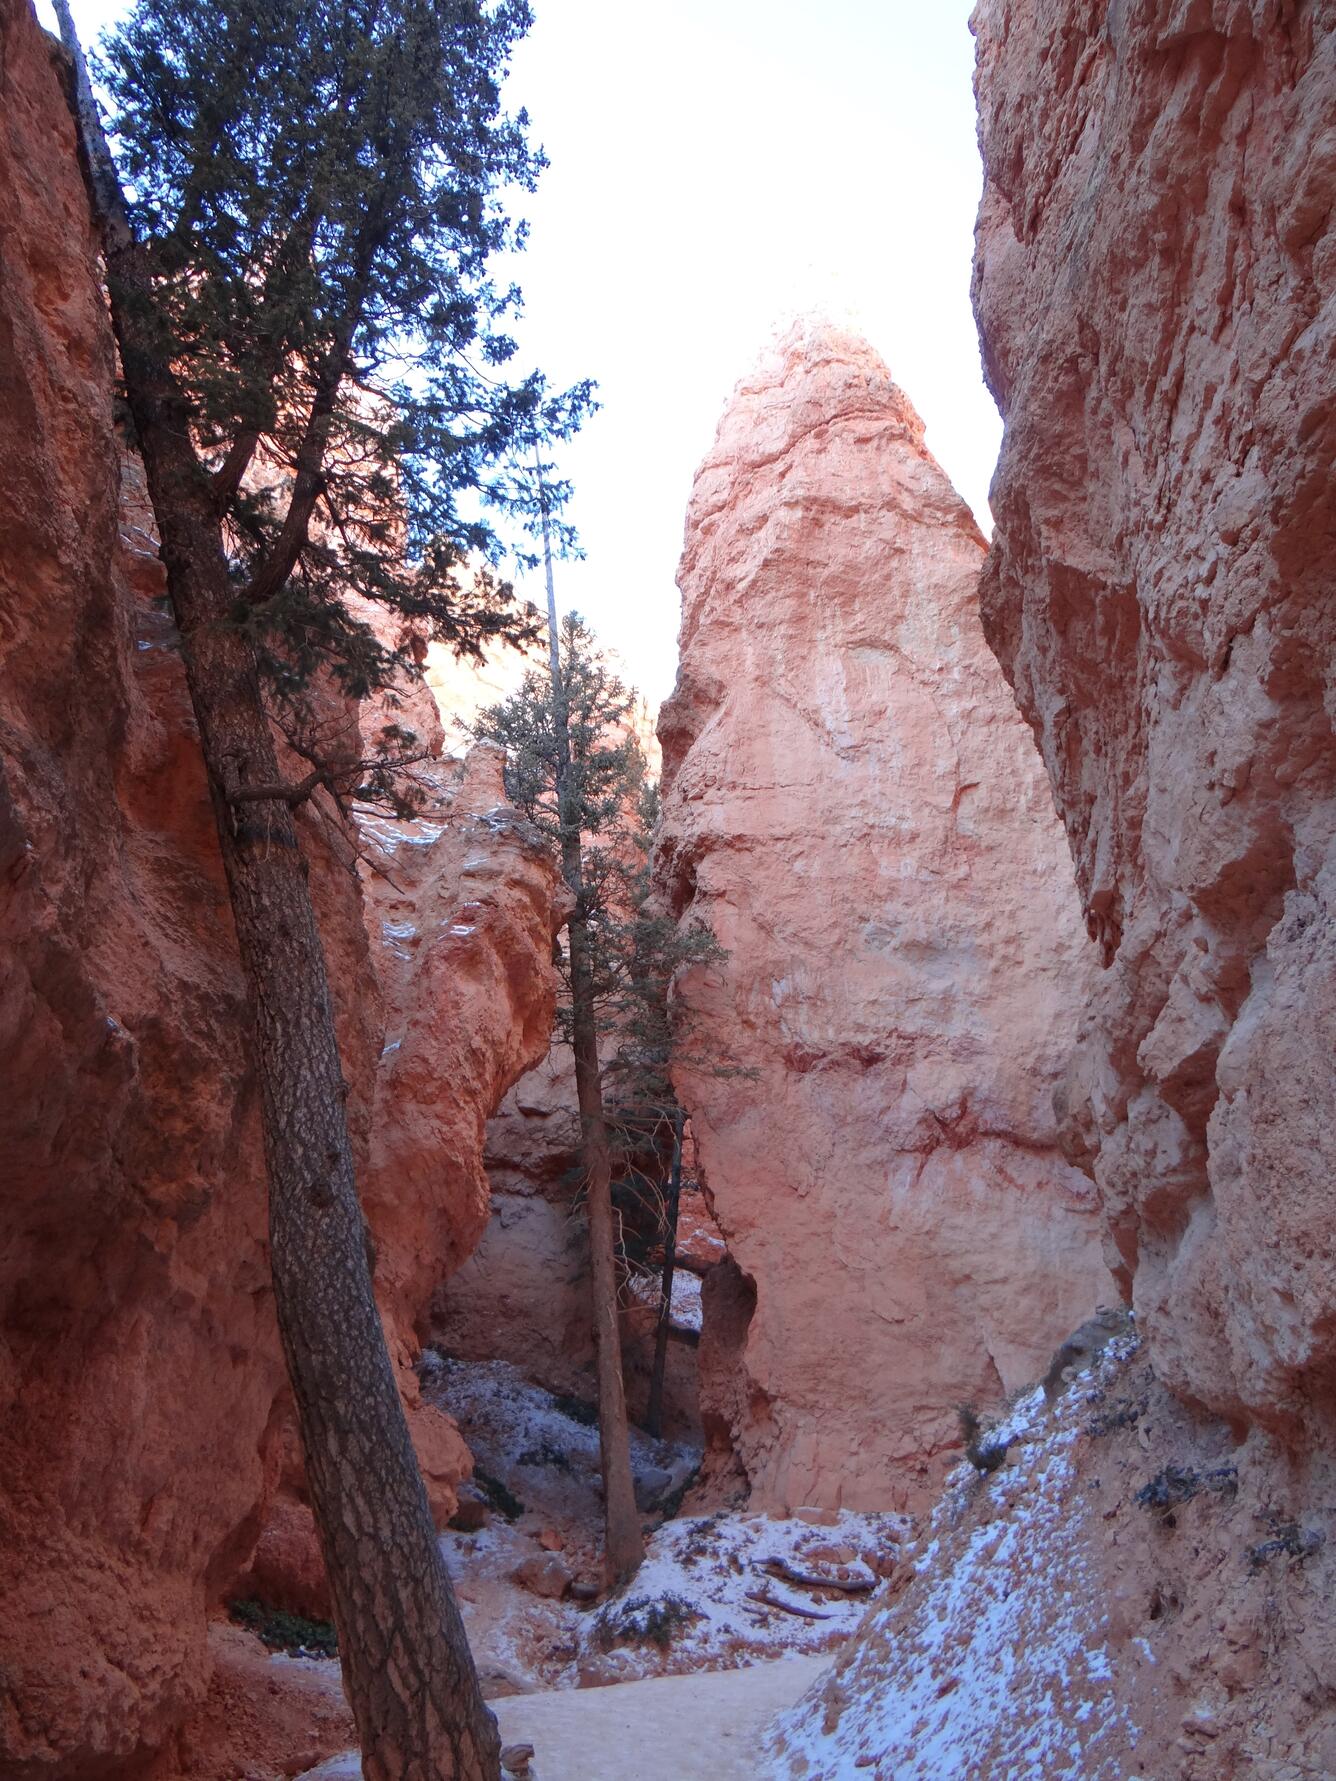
773;0;1336;1781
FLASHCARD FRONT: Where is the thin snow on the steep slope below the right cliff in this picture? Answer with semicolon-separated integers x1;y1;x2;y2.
769;1339;1136;1781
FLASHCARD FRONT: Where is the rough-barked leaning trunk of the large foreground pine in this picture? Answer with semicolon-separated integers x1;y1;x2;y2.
57;10;501;1781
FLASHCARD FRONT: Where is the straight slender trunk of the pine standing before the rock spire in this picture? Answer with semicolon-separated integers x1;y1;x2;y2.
540;468;645;1589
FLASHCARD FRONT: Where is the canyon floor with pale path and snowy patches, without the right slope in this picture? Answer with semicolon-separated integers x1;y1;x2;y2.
297;1354;910;1781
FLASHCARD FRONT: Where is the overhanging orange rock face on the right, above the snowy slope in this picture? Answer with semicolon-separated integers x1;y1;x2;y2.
974;0;1336;1439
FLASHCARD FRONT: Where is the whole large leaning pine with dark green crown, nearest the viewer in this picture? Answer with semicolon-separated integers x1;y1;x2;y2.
57;0;590;1781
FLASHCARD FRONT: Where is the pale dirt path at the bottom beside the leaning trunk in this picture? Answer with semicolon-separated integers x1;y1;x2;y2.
303;1658;830;1781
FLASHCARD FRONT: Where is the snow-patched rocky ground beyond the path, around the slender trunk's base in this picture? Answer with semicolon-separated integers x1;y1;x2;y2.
422;1354;910;1696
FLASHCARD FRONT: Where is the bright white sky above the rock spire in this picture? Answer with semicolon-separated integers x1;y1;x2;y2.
41;0;1001;702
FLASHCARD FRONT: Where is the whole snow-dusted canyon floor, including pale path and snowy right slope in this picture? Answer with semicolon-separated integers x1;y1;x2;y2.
292;1341;1161;1781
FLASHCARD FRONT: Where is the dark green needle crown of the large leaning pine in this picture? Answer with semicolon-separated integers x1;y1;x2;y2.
98;0;591;696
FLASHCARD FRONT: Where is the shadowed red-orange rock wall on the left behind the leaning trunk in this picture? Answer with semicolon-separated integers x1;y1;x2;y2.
0;0;566;1777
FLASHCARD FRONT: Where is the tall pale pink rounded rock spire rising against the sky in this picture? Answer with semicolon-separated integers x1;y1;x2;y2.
659;324;1112;1507
